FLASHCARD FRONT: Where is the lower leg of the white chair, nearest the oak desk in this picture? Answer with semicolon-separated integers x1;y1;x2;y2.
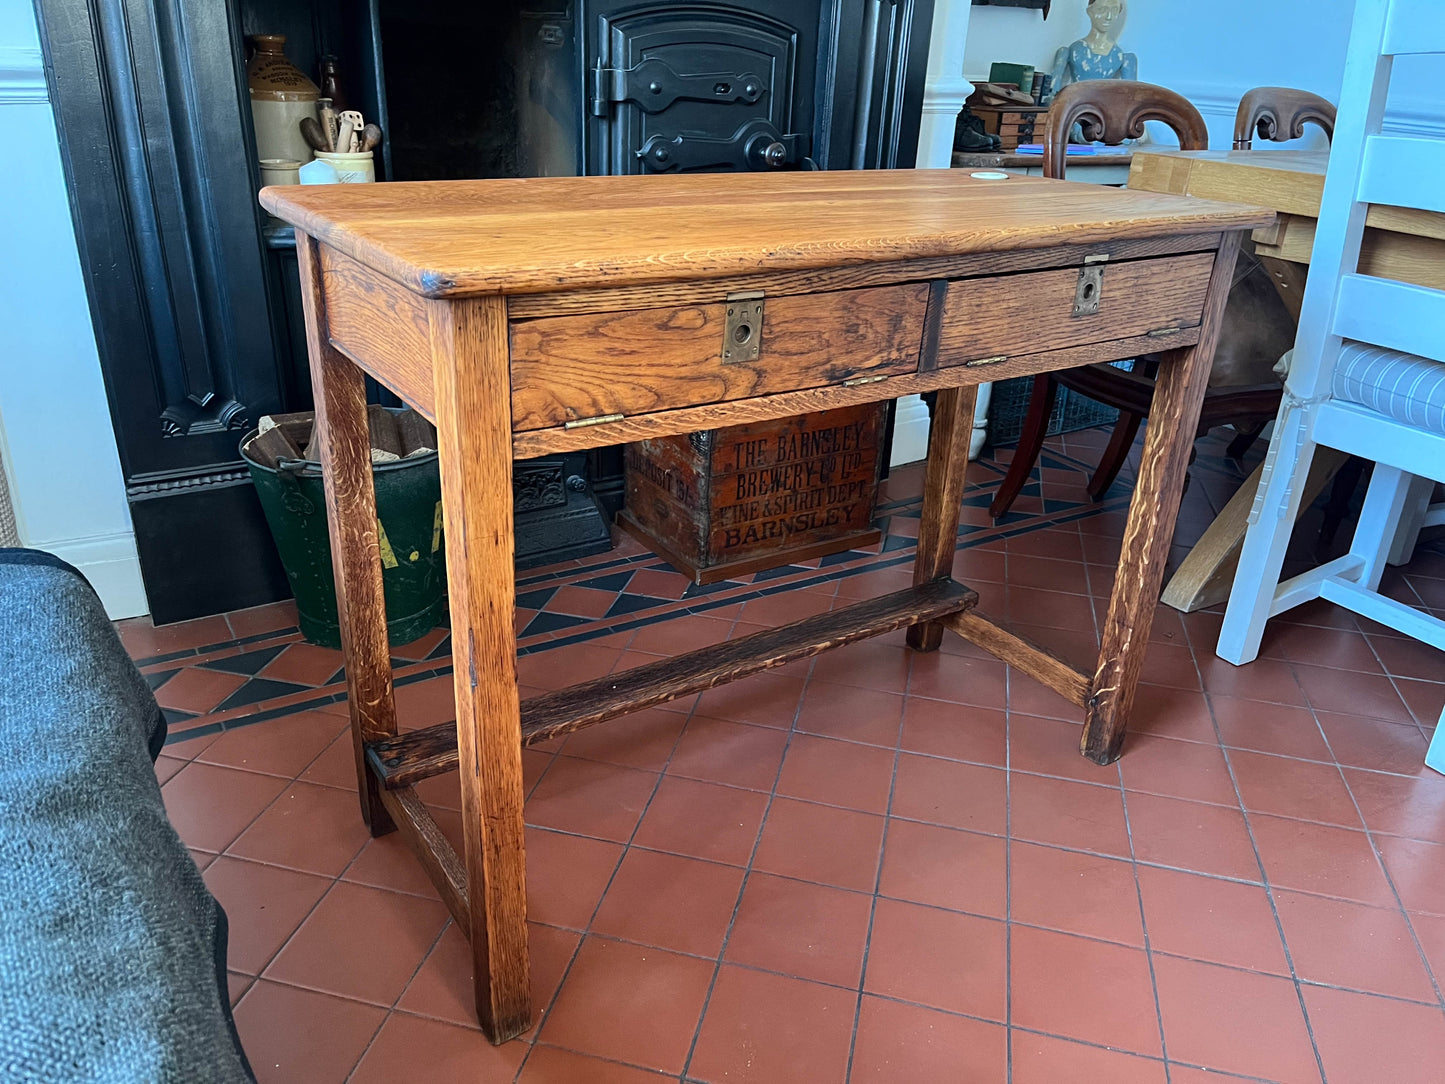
1215;419;1316;666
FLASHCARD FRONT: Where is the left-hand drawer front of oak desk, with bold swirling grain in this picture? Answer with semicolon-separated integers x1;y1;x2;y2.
510;283;928;431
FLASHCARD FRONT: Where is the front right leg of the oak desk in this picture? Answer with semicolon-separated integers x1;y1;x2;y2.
1081;233;1240;765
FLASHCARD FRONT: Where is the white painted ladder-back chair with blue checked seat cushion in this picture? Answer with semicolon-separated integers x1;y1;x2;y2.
1218;0;1445;772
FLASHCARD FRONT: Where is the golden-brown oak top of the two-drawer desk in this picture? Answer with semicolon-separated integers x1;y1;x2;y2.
260;169;1270;298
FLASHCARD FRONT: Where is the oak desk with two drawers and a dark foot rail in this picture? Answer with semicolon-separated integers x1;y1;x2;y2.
262;171;1270;1042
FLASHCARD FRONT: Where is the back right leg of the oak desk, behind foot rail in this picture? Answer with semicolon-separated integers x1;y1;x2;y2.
907;384;978;652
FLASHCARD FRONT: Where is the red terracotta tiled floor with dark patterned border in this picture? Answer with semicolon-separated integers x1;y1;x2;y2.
123;432;1445;1084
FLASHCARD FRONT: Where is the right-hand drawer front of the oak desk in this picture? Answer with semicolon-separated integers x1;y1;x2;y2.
938;253;1214;367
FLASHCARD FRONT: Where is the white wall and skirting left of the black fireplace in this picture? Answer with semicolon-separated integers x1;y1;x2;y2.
0;0;147;617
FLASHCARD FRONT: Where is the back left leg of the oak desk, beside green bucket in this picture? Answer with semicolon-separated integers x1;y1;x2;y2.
296;230;396;835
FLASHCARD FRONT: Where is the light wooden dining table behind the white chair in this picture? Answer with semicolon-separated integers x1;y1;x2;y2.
1129;147;1445;613
